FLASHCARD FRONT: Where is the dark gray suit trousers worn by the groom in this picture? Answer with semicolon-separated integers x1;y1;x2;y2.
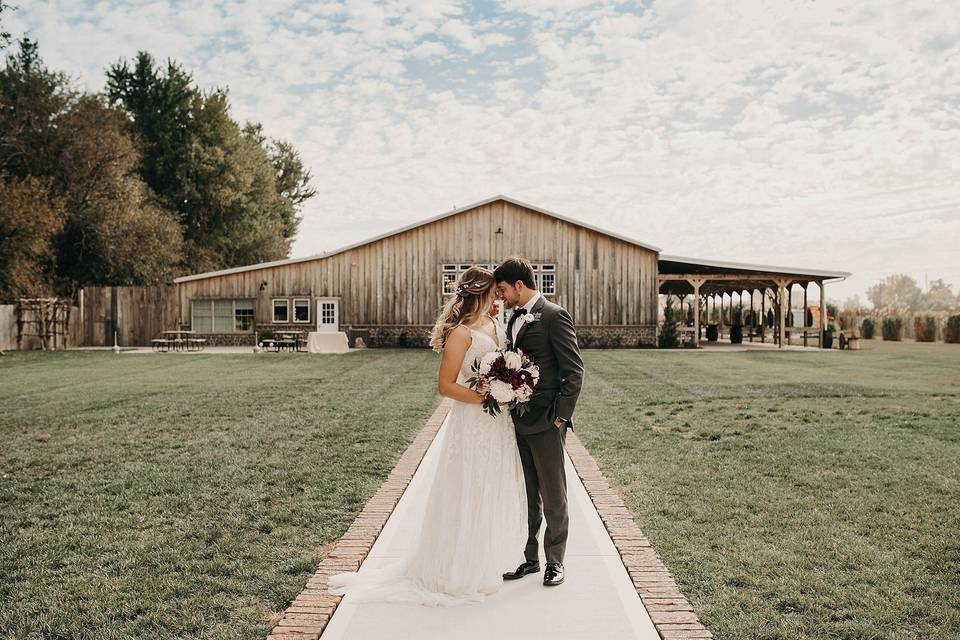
517;425;569;562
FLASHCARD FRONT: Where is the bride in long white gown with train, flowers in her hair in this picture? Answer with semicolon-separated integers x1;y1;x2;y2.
328;266;527;606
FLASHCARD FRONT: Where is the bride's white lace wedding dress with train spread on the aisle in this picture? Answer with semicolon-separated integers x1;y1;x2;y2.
328;322;527;606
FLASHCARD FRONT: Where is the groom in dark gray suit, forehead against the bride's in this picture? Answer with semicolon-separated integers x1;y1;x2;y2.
493;257;583;586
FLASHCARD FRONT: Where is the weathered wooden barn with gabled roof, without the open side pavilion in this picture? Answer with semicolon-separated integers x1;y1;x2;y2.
175;196;660;346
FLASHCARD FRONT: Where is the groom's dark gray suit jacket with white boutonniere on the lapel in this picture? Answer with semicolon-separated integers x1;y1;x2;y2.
507;294;583;434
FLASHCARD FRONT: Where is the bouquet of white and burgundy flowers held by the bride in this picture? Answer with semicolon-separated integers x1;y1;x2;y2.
466;349;540;416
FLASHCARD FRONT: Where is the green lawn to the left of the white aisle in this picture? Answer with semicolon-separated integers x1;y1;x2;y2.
0;350;439;640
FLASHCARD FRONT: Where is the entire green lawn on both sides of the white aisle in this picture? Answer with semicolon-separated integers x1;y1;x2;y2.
0;341;960;640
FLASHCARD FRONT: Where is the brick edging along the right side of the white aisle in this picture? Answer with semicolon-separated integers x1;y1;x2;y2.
566;431;713;640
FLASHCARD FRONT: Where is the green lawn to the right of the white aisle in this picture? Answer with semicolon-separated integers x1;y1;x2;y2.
577;341;960;640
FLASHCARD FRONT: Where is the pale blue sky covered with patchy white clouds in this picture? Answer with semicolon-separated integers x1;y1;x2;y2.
3;0;960;302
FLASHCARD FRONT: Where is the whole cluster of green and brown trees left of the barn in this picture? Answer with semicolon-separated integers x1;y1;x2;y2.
0;41;315;297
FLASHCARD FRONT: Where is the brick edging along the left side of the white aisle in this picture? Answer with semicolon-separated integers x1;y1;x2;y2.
267;398;453;640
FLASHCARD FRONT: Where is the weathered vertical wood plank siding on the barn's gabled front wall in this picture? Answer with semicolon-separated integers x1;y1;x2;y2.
174;201;657;326
